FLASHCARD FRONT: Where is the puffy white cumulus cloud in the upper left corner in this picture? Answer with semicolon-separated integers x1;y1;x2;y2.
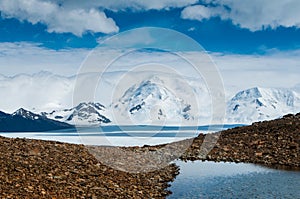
0;0;119;36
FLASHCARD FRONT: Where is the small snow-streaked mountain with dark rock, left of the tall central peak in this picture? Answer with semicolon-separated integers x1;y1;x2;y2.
42;102;111;126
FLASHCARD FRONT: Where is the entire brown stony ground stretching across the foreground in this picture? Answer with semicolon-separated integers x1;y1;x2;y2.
0;114;300;198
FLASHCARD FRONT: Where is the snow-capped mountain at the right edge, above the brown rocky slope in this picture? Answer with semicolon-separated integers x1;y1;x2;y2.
226;87;300;124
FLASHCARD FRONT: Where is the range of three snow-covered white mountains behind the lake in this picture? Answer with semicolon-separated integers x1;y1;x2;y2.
38;84;300;126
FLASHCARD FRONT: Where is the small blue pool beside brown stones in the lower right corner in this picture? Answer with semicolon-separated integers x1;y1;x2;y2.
168;161;300;199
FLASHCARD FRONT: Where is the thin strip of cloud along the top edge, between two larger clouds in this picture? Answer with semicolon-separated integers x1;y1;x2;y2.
56;0;198;11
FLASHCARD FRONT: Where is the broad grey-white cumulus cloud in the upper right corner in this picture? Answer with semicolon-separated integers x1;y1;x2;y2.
182;0;300;31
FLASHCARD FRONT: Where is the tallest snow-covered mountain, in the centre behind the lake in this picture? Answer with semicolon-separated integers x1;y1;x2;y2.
111;77;195;124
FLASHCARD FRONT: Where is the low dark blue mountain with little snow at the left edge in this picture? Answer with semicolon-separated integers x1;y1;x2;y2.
0;108;74;132
